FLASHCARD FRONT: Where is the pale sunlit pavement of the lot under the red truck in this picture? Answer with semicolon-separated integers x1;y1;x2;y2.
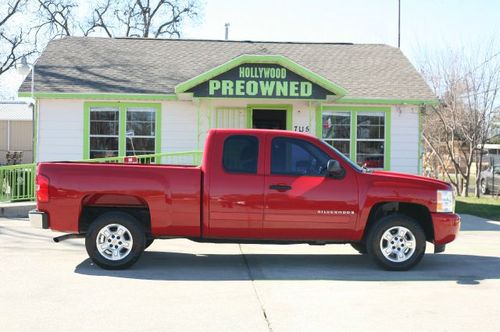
0;216;500;331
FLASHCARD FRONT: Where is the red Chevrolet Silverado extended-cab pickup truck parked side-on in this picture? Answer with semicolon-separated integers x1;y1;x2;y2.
30;129;460;270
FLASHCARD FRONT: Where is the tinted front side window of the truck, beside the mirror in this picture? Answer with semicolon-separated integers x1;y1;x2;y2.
271;137;330;176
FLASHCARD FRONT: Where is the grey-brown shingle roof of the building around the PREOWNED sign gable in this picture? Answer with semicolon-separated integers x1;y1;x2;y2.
20;37;435;100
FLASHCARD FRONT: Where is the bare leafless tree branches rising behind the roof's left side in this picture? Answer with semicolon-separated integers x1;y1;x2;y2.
36;0;199;38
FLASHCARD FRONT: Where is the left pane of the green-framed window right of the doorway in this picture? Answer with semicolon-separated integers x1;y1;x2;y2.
322;112;351;157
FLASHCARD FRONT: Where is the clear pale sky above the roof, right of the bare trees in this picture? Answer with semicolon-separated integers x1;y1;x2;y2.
0;0;500;98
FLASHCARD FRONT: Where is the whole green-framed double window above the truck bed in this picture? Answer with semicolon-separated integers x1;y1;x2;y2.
84;103;161;159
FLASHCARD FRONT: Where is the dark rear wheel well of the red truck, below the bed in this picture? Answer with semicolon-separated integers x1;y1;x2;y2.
78;206;151;234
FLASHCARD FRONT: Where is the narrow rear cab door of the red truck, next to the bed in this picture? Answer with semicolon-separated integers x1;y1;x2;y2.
204;131;265;239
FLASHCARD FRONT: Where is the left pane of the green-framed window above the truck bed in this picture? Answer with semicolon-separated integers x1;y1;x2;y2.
89;107;120;158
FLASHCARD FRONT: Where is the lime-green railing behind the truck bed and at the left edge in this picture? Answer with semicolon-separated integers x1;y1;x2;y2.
0;151;202;202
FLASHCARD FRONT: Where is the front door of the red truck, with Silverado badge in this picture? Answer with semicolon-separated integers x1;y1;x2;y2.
263;136;358;240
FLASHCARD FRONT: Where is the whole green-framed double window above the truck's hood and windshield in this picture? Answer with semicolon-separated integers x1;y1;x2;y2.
318;106;390;169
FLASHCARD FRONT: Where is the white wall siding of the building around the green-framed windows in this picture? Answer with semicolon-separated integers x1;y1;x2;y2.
37;99;419;174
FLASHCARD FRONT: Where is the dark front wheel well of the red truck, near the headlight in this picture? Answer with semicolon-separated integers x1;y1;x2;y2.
363;202;434;241
